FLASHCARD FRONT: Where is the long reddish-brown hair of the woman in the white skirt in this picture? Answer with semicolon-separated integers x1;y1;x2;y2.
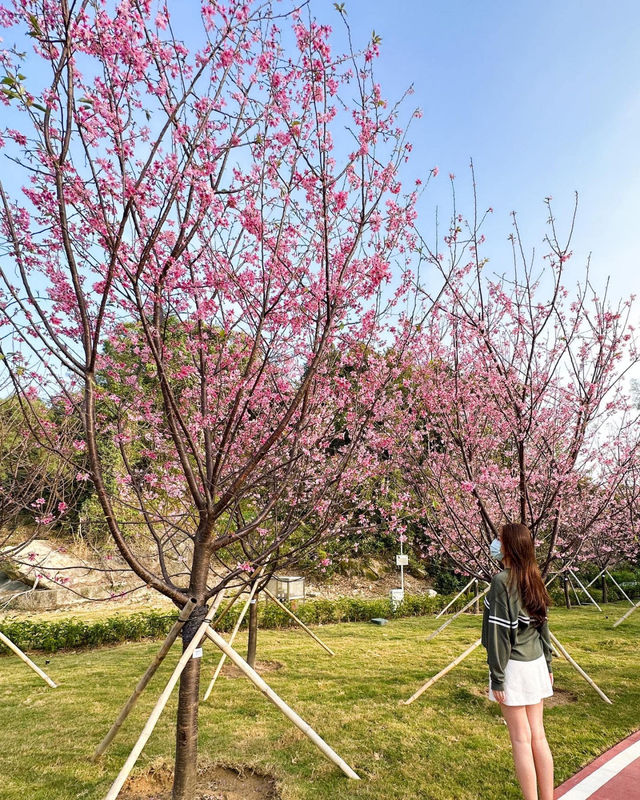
500;522;551;627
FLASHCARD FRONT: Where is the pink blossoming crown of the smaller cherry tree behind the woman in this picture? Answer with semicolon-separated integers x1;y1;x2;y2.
394;187;638;579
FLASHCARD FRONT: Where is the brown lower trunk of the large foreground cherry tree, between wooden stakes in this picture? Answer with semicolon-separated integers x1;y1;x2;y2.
172;606;207;800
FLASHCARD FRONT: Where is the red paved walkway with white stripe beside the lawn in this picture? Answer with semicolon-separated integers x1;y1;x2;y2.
553;731;640;800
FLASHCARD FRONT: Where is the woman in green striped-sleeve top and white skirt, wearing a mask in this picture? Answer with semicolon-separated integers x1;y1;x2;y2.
482;523;553;800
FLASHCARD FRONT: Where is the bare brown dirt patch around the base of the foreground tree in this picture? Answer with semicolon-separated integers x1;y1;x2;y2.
120;763;280;800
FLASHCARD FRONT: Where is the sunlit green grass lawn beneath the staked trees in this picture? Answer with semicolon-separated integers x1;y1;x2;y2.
0;604;640;800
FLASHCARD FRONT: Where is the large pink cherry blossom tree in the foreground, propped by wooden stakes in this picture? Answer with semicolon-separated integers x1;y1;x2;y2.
0;0;415;800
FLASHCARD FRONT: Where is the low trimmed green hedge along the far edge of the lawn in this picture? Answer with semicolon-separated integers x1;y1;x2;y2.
0;594;471;653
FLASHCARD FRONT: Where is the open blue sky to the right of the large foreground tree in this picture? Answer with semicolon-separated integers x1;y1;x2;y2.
324;0;640;310
